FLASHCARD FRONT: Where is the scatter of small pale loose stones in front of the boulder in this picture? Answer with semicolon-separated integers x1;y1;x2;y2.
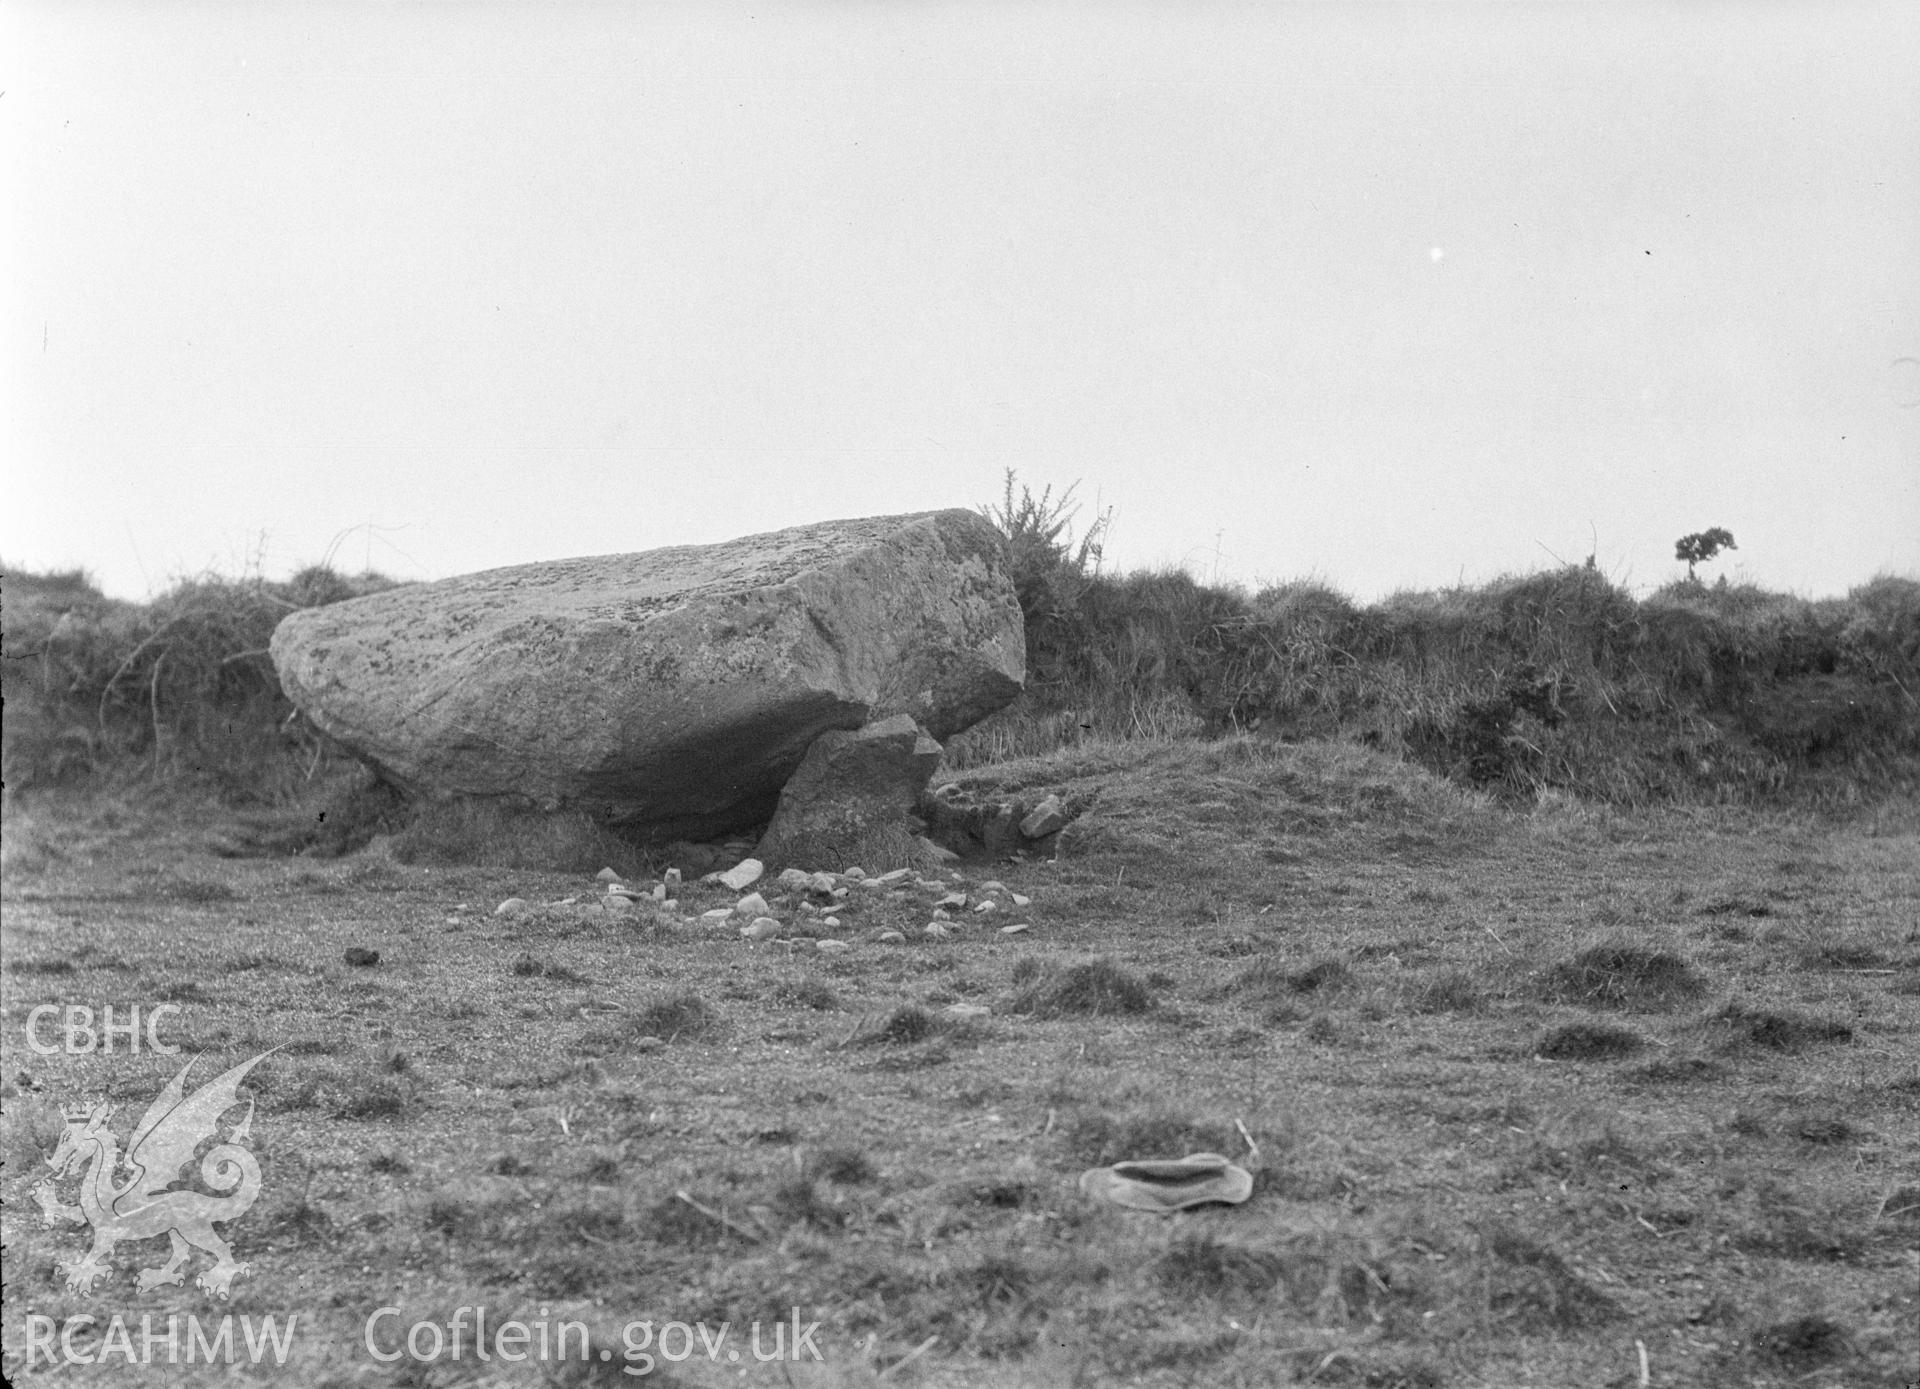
493;859;1033;955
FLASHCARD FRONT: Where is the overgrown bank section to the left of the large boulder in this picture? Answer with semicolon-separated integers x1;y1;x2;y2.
0;567;394;801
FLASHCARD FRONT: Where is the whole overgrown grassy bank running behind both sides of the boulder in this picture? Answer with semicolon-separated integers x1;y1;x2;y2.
4;522;1920;829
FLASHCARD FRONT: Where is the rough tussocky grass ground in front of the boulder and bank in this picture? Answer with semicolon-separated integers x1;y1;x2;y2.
0;740;1920;1387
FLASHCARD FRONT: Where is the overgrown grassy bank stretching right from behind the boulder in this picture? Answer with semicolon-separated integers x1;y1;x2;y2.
948;553;1920;805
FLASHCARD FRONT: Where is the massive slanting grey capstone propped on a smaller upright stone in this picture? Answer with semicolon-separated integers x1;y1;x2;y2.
273;511;1025;838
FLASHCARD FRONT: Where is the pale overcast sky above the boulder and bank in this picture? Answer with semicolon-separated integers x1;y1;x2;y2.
0;0;1920;597
